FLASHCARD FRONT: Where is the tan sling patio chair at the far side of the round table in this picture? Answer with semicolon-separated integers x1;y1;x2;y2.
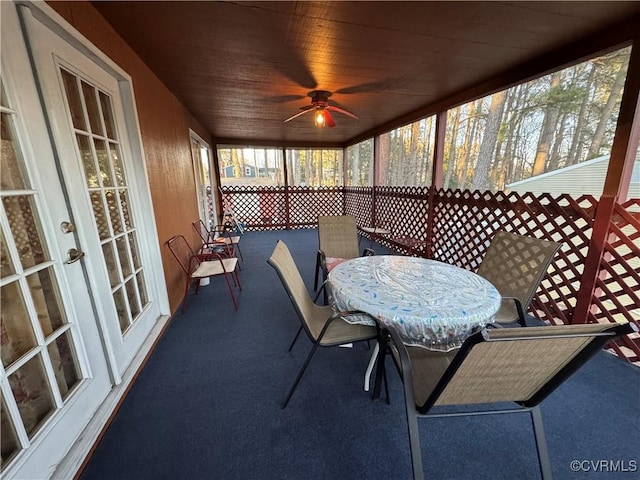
313;215;375;298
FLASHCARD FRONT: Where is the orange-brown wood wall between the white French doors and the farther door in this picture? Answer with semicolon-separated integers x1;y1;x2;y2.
48;1;213;312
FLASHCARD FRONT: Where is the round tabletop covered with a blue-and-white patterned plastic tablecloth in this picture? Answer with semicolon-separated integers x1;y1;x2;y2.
328;255;501;351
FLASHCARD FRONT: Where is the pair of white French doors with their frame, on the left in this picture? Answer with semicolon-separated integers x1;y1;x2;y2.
0;1;169;479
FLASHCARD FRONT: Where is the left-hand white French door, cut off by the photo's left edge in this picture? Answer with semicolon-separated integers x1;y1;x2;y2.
0;2;112;478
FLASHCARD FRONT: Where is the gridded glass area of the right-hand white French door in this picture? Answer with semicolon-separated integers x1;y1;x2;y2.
62;69;149;332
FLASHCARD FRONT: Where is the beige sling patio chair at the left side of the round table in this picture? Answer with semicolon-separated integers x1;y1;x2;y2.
267;240;378;408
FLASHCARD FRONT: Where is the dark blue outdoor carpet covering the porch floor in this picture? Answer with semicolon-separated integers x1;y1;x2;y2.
80;229;640;480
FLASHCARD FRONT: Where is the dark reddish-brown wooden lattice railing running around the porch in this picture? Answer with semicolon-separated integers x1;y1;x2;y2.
222;187;640;365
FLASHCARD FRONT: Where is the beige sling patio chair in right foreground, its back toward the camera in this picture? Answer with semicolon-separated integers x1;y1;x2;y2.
381;323;637;480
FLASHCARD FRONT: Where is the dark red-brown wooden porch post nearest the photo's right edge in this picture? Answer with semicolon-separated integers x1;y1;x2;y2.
571;37;640;323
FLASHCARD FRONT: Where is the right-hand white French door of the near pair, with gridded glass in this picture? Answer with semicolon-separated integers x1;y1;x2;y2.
20;1;166;379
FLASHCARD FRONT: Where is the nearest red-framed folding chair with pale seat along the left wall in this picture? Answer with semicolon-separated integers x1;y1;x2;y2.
167;235;242;313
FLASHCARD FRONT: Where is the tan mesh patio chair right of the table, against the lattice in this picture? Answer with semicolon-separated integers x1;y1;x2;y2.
476;231;560;326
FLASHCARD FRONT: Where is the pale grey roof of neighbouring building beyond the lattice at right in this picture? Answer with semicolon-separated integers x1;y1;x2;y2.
505;155;640;198
